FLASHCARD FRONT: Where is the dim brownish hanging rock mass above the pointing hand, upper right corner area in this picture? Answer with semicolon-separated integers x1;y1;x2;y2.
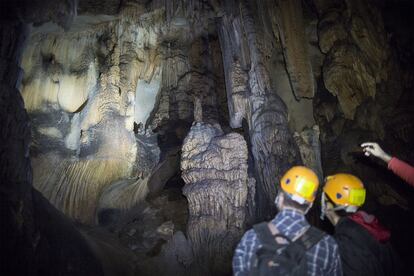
318;1;390;119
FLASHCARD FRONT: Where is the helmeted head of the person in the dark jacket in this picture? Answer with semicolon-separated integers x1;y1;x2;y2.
321;173;366;225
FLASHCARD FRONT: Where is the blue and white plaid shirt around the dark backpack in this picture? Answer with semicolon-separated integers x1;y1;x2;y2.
233;209;342;276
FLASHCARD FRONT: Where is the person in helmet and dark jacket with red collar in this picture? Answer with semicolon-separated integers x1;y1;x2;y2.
321;173;397;275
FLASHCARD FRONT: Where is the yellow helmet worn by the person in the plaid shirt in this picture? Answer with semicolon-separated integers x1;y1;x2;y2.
280;166;319;204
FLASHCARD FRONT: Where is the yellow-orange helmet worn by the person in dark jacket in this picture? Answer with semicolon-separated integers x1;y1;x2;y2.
323;173;366;207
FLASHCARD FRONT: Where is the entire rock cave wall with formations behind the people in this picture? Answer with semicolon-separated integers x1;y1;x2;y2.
0;0;414;276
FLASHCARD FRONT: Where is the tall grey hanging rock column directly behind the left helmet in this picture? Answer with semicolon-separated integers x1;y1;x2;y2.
219;1;300;217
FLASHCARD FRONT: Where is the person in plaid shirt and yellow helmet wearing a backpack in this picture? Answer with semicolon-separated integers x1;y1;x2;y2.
233;166;342;276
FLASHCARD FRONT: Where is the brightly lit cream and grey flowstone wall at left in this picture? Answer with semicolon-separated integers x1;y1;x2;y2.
21;1;233;224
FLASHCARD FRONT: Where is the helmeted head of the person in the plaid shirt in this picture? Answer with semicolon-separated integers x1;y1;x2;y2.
275;166;319;214
